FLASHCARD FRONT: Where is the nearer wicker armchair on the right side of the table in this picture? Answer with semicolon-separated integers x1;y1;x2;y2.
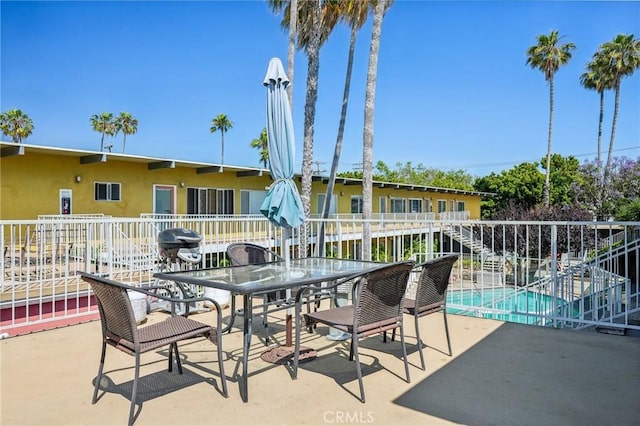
293;262;414;402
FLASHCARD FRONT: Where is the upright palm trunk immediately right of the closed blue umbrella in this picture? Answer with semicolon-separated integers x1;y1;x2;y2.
298;0;321;257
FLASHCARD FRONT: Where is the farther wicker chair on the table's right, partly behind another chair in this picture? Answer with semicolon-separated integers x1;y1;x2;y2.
391;254;458;370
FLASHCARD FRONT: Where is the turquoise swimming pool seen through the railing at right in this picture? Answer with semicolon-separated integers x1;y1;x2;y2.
447;288;576;325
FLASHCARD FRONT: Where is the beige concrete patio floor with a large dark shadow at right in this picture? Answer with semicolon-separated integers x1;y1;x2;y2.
0;302;640;425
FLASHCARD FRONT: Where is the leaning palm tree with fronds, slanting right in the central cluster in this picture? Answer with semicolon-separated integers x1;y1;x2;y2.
318;0;372;256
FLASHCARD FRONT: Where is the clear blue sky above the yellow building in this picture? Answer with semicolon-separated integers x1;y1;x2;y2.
0;0;640;176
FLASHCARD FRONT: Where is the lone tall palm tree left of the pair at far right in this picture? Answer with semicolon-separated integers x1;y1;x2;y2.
527;30;576;207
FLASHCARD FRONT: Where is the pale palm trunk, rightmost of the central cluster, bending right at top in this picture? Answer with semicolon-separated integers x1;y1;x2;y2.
362;0;393;260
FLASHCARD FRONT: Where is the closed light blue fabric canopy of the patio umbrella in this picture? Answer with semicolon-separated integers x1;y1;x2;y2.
260;58;304;228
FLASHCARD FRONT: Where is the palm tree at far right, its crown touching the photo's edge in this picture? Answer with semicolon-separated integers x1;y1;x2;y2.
600;34;640;185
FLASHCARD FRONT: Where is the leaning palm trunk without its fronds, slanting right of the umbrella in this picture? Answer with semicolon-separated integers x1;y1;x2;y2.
318;26;358;256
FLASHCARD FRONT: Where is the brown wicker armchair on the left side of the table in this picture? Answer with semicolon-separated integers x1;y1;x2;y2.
80;272;228;425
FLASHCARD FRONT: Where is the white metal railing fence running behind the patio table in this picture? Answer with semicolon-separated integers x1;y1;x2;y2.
0;215;640;335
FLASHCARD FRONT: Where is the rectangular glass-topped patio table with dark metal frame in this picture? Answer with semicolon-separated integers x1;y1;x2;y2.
154;257;381;402
